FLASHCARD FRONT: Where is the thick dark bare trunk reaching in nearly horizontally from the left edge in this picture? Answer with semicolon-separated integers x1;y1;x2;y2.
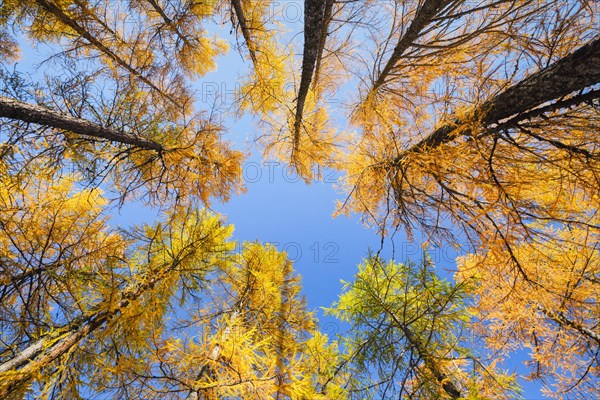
0;96;164;152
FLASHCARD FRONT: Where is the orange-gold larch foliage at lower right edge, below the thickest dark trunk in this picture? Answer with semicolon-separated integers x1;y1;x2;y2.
457;212;600;399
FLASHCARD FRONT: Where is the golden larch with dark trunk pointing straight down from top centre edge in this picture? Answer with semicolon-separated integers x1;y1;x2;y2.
241;0;360;182
